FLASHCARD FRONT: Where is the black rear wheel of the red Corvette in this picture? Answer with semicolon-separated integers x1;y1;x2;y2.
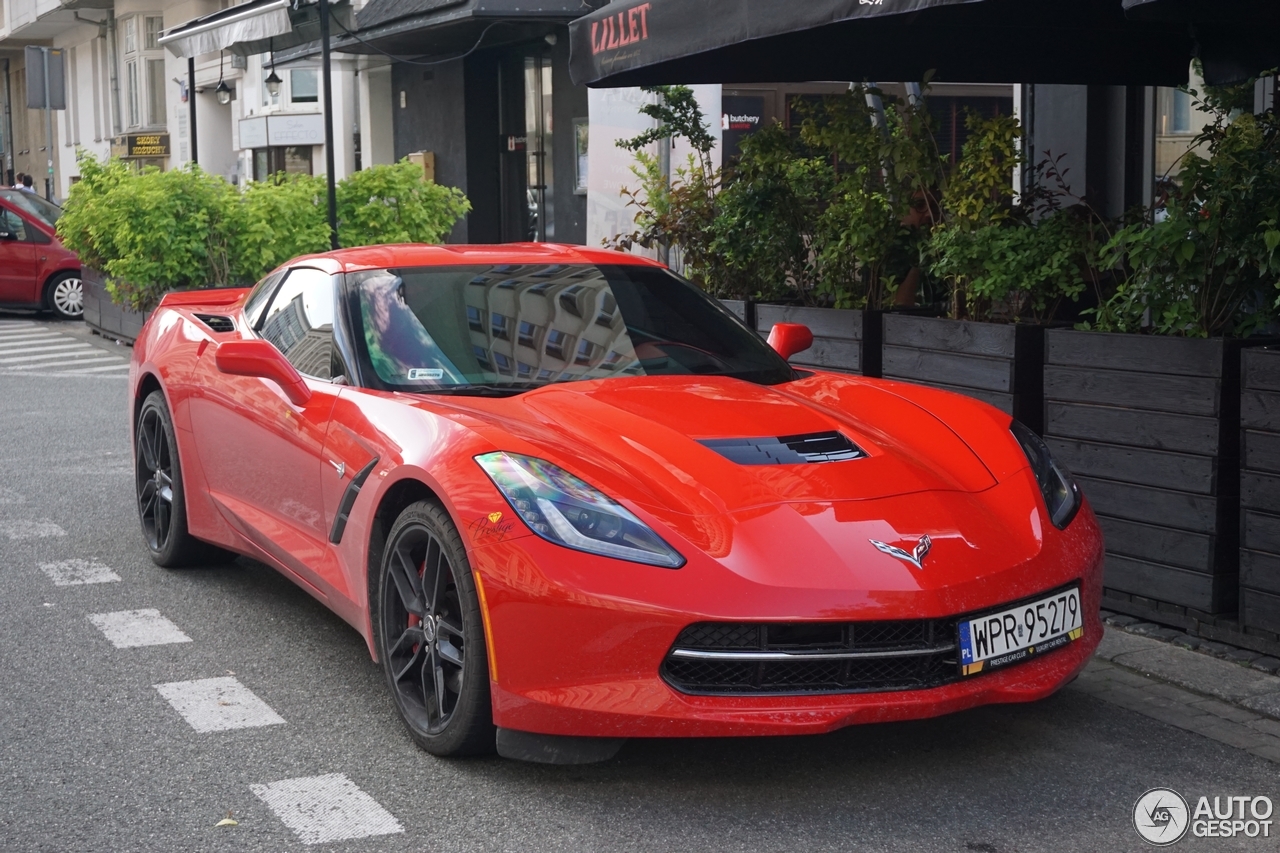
133;391;236;569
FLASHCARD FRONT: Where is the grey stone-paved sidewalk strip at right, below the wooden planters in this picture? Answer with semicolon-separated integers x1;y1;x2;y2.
1073;626;1280;763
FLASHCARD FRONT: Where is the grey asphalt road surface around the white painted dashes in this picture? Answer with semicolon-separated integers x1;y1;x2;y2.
0;315;1280;853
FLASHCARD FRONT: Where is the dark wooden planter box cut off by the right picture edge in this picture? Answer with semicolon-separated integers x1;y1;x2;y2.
1240;348;1280;634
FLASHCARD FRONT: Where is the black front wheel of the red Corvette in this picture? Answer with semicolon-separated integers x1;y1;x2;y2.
370;501;495;756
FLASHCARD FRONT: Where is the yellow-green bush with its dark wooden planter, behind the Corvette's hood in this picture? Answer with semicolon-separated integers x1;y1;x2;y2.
883;115;1101;433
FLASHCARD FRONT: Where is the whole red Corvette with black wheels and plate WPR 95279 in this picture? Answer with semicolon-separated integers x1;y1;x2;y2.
129;245;1102;762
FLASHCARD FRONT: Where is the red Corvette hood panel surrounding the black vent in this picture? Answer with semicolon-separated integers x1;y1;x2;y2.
440;375;996;516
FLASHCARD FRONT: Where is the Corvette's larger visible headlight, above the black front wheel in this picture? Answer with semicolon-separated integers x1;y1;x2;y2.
476;451;685;569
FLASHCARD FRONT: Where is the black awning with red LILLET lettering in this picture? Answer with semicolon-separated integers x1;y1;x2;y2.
570;0;1198;86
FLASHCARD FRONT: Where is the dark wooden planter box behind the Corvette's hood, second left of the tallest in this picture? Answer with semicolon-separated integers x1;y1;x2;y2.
883;314;1044;433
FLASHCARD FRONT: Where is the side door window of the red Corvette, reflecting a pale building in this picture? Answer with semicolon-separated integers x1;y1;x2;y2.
261;269;334;379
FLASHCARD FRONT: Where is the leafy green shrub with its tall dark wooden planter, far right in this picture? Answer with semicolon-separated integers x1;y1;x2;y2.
1044;78;1280;612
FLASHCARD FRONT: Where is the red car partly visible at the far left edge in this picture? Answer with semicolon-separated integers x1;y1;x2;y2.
0;190;84;320
